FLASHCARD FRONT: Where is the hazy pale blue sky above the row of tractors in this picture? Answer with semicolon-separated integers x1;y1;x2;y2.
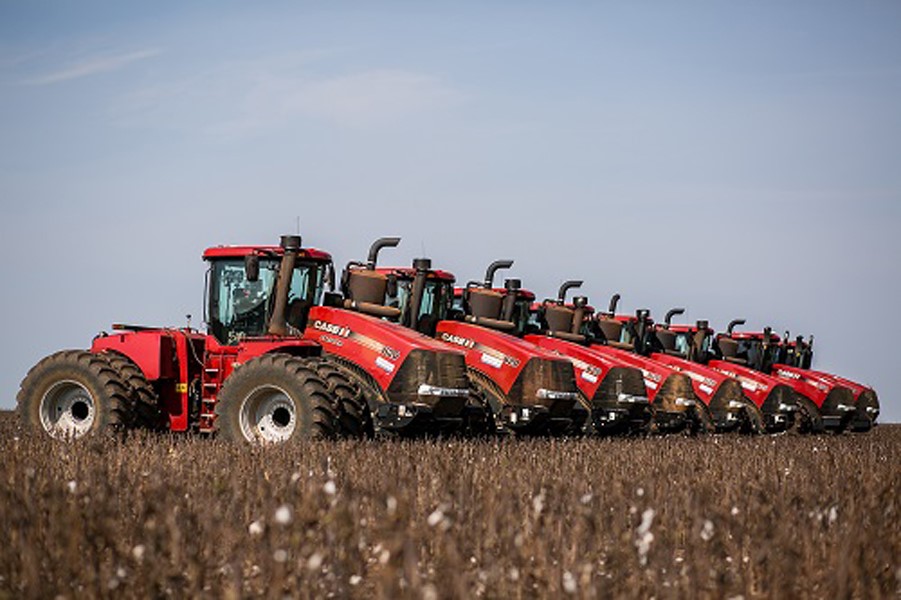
0;1;901;421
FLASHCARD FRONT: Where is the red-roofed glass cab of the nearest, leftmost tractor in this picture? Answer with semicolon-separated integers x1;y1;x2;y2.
203;236;333;346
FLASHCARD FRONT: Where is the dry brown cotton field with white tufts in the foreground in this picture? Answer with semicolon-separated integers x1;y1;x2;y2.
0;415;901;598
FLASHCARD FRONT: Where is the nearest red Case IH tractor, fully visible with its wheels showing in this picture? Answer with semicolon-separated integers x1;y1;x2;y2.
17;236;469;443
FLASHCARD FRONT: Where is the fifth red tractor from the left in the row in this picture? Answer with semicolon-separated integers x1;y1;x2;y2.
606;294;764;433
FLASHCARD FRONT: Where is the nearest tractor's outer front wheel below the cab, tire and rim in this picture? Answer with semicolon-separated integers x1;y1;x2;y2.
216;354;340;444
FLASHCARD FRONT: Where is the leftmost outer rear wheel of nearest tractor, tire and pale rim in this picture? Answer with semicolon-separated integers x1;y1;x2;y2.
16;350;132;440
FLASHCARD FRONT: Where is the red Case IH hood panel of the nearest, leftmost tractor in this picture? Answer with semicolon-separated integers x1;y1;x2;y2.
304;306;462;390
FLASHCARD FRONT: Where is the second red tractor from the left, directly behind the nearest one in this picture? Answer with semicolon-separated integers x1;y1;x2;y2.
378;259;588;435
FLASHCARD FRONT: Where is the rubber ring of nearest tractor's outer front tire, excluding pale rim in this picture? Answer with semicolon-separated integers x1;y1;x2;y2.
216;353;340;443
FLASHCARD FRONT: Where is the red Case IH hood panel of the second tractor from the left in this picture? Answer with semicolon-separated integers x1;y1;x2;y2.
436;321;569;394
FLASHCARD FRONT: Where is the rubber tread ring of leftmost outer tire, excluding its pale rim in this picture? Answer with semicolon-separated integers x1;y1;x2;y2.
16;350;134;436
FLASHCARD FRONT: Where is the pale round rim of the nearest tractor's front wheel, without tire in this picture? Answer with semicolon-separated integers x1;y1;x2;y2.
239;385;297;444
